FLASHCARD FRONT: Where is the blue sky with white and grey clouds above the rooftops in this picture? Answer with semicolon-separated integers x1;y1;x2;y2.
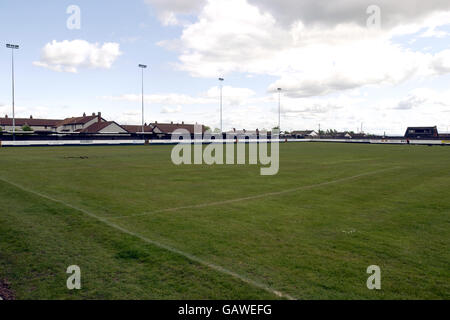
0;0;450;134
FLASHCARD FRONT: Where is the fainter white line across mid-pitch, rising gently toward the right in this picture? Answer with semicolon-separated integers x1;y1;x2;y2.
107;167;399;219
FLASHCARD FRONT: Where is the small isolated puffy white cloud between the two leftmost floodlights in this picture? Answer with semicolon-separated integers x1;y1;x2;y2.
33;40;121;73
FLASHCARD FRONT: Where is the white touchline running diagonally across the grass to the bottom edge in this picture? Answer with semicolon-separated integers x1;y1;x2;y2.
0;177;295;300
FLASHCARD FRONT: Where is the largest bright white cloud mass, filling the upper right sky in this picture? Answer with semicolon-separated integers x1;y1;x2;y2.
159;0;450;97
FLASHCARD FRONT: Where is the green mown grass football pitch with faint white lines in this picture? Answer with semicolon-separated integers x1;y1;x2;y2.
0;143;450;299
